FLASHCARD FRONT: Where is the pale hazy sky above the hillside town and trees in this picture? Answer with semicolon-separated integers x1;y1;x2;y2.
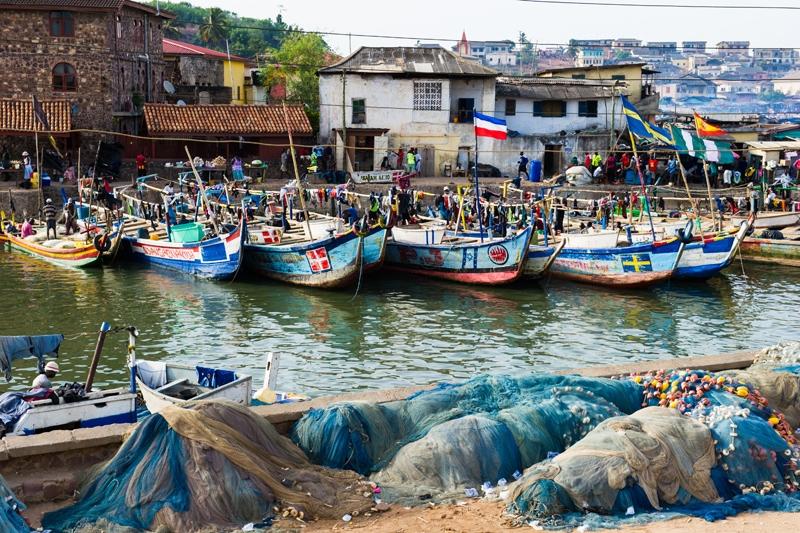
183;0;800;55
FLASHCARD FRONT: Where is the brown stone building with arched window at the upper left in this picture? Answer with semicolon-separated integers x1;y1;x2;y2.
0;0;174;144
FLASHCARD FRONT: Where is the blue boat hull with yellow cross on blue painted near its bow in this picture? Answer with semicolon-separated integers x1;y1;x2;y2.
550;239;685;288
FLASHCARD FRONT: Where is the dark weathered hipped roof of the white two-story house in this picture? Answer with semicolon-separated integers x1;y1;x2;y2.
318;46;499;77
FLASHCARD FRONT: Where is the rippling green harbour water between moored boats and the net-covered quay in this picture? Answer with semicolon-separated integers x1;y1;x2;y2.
0;251;800;395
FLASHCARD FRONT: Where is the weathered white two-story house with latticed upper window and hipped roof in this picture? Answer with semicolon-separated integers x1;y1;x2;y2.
318;47;498;176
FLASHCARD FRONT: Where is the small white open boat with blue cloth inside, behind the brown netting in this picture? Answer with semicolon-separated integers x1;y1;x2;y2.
135;360;253;413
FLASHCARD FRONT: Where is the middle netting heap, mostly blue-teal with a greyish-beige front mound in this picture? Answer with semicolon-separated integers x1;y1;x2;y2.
292;375;641;498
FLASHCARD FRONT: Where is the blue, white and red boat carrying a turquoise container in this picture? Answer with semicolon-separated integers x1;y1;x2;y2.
123;219;247;280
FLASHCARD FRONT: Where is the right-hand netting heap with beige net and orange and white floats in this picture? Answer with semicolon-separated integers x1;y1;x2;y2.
508;367;800;526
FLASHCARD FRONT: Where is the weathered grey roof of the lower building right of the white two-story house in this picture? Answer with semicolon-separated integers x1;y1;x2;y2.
496;78;614;100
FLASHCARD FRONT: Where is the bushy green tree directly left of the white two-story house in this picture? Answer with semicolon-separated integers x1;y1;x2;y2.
264;33;332;130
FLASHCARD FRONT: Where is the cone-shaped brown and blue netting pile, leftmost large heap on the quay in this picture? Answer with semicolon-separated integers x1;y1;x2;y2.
43;401;372;531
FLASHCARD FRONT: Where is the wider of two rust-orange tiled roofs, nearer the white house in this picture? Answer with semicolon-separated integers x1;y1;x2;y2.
144;104;313;137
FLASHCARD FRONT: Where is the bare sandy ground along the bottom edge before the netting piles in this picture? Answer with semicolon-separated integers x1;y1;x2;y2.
274;501;800;533
